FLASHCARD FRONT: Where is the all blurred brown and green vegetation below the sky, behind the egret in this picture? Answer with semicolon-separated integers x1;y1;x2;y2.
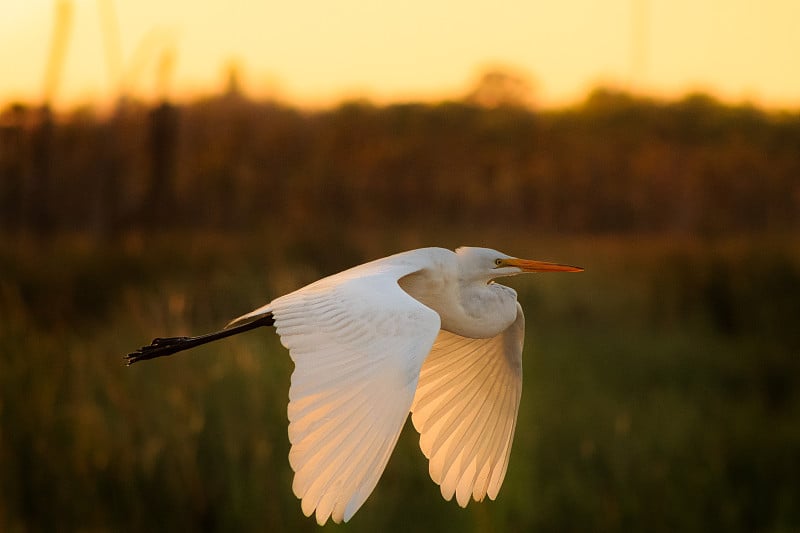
0;83;800;532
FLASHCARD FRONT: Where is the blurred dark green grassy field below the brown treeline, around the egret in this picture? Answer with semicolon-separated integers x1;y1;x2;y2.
0;231;800;532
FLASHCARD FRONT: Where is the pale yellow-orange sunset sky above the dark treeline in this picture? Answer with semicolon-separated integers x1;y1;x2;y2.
0;0;800;109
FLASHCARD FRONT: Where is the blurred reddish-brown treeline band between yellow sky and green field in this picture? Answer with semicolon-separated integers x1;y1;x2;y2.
0;90;800;236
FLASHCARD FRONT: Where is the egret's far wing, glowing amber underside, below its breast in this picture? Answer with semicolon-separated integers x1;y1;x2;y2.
411;304;525;507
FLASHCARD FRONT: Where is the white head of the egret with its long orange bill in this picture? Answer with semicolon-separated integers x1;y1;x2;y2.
456;246;583;282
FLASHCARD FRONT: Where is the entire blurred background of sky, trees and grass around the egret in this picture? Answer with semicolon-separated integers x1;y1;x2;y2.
0;0;800;532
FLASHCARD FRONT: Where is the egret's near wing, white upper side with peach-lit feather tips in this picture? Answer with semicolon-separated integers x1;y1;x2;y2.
234;256;440;525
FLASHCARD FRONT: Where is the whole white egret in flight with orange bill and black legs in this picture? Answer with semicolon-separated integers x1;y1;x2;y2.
126;247;583;525
